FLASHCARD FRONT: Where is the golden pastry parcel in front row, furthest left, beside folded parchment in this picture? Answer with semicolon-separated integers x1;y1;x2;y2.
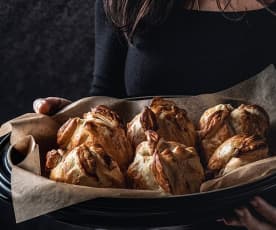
46;144;125;188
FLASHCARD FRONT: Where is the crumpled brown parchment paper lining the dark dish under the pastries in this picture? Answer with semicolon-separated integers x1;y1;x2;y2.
0;65;276;223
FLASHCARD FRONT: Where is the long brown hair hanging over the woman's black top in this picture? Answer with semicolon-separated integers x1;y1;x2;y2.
103;0;274;42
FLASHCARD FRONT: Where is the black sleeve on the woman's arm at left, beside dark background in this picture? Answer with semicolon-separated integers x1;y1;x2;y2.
91;0;127;97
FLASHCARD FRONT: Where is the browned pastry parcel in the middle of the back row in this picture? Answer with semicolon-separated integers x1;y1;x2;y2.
128;97;197;148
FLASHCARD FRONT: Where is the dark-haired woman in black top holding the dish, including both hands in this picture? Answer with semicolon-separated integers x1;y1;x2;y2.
34;0;276;230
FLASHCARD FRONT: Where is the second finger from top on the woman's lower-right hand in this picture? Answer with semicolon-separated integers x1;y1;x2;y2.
235;208;275;230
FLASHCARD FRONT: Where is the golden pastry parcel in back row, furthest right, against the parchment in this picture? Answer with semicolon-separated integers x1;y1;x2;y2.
199;104;269;163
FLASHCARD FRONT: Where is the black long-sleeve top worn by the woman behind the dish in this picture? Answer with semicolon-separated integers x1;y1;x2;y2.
91;0;276;97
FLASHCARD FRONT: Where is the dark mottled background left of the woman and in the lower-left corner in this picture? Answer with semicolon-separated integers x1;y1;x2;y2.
0;0;95;230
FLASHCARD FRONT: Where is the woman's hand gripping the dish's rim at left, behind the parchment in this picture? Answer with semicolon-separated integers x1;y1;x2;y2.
33;97;71;115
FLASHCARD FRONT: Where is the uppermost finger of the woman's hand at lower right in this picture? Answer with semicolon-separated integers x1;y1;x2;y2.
250;197;276;225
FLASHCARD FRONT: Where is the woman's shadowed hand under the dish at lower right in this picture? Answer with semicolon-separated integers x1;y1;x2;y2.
224;197;276;230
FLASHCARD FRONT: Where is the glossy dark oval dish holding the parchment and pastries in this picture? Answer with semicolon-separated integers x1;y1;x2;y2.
0;133;276;228
